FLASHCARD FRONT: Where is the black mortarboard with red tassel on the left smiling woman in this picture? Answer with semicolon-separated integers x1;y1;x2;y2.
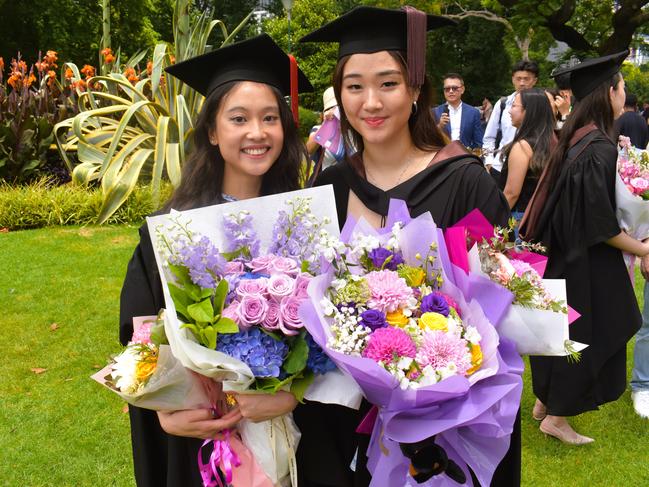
166;34;313;96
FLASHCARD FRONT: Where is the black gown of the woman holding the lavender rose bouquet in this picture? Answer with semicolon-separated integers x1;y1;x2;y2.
119;224;207;487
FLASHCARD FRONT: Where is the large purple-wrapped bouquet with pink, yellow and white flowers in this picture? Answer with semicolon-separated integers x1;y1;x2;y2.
303;201;522;486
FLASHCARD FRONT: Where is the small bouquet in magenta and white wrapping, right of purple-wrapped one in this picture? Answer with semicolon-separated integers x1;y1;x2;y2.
447;210;587;360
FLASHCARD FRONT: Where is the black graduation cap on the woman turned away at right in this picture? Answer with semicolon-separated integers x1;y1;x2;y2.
552;50;629;100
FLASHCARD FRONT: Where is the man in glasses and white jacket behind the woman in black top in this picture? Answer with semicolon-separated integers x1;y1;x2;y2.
482;61;539;181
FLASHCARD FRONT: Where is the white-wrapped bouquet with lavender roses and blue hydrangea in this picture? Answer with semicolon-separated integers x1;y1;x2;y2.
148;188;361;485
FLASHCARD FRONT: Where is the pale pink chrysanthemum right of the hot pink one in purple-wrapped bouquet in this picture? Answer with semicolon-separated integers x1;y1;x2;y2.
415;330;471;375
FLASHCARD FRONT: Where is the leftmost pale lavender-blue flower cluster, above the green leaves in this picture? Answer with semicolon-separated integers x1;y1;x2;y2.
171;237;225;288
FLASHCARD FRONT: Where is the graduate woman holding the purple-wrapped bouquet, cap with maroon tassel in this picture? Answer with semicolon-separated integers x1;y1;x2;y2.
294;7;520;487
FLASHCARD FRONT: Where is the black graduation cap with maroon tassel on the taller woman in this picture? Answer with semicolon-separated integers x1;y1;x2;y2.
300;6;455;86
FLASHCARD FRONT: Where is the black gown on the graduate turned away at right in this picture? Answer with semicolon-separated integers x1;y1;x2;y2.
530;125;641;416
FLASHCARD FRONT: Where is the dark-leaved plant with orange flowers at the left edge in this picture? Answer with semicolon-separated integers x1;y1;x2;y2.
0;51;76;183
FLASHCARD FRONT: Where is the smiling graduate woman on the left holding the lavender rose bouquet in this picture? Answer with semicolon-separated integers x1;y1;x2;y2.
120;35;312;487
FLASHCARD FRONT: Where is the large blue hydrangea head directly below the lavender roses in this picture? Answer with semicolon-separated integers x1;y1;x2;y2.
216;327;288;377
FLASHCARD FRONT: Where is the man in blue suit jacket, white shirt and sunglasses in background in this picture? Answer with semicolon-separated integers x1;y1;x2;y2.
435;73;484;149
